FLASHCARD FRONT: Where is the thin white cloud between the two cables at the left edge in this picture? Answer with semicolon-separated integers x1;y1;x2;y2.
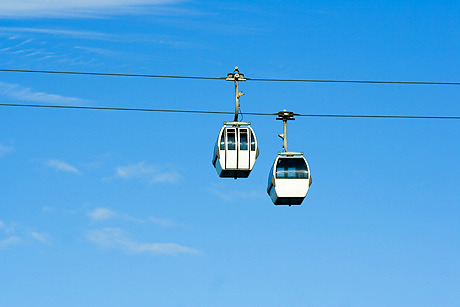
0;81;85;104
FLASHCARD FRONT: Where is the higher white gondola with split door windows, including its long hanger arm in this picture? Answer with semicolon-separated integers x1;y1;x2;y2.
212;67;259;179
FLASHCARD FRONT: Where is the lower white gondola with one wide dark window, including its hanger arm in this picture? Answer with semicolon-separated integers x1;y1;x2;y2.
267;110;312;206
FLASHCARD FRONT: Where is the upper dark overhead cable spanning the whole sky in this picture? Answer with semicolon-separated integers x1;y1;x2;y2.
0;69;460;85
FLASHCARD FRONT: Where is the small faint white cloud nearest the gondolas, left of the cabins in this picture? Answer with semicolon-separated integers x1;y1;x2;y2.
111;162;182;183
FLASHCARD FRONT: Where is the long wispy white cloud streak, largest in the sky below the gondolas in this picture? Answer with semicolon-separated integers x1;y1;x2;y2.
86;228;201;255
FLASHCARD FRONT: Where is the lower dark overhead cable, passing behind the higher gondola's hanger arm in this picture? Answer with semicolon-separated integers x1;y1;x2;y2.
0;103;460;120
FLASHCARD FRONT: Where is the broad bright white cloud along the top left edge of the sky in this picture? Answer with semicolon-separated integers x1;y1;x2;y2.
0;0;184;18
